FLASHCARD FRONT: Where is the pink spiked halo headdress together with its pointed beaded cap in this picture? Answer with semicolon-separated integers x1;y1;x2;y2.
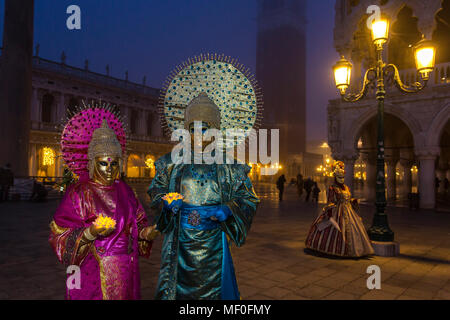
61;104;126;178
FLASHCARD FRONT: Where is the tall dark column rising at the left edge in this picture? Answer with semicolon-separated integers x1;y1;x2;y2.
0;0;34;176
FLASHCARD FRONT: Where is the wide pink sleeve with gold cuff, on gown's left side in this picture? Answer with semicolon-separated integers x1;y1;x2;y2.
49;188;92;266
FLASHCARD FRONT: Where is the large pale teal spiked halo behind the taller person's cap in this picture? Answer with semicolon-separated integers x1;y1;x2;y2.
159;54;263;143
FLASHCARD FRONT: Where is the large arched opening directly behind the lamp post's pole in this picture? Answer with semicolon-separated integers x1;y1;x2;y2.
353;113;417;202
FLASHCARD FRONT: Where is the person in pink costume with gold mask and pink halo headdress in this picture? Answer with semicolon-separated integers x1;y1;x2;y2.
49;107;157;300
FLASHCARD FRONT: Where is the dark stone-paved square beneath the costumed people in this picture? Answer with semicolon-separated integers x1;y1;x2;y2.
0;184;450;300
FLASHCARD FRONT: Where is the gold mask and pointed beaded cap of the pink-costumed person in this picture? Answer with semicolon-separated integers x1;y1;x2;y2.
88;121;122;185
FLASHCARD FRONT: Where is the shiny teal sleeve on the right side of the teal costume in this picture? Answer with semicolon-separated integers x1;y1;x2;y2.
221;165;260;247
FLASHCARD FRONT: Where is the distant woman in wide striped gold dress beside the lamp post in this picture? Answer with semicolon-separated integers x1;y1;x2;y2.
305;161;374;257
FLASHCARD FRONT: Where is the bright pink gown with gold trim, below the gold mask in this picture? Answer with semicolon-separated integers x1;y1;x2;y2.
49;180;152;300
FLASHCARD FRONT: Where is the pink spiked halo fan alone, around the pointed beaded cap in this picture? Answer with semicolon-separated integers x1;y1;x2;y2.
61;102;126;178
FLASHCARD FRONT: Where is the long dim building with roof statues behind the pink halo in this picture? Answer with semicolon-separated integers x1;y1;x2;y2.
28;53;172;178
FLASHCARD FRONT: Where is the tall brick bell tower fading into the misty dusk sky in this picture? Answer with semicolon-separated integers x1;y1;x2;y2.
256;0;306;163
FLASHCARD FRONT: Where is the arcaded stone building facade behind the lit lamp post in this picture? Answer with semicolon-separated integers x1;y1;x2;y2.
328;0;450;208
